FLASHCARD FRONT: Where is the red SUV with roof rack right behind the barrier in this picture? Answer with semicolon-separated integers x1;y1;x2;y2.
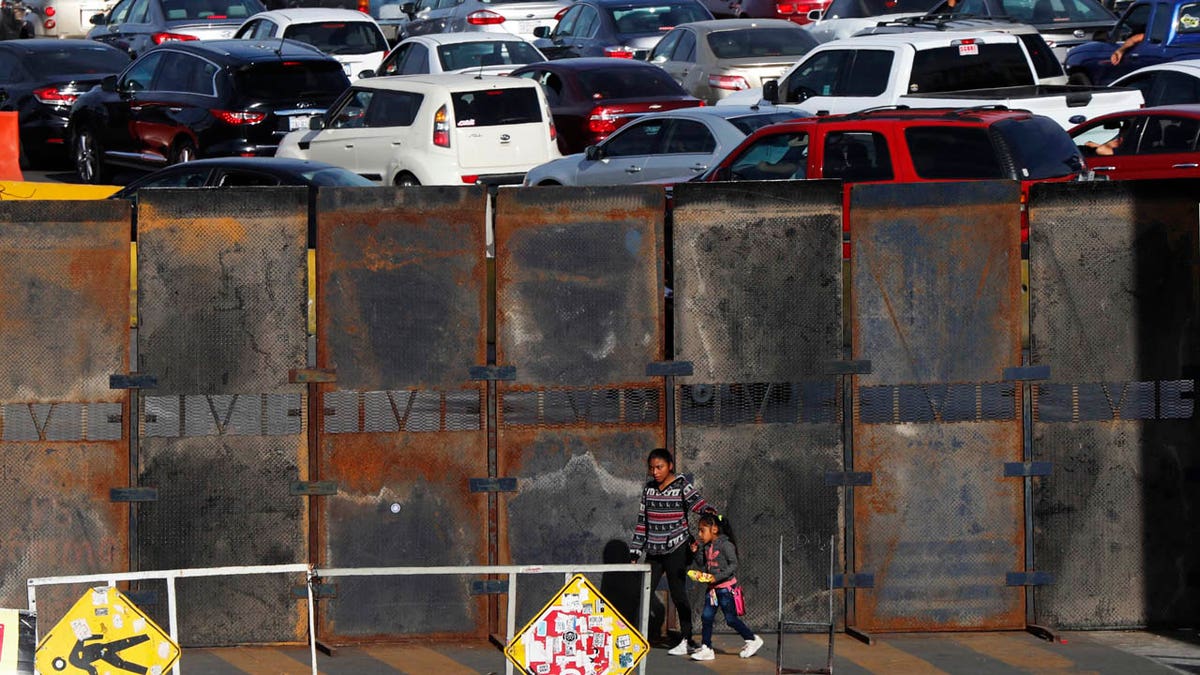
696;107;1084;257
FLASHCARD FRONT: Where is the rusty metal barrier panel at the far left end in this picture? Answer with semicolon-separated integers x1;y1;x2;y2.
0;201;130;617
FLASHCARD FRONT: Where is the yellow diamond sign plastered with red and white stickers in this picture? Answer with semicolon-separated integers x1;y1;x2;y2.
504;574;649;675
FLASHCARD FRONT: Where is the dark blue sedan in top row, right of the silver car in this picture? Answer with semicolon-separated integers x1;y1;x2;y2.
534;0;713;59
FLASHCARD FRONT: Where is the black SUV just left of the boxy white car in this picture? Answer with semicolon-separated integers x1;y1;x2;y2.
70;40;349;183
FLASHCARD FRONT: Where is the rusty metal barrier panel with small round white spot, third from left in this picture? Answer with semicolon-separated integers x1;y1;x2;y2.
313;187;488;641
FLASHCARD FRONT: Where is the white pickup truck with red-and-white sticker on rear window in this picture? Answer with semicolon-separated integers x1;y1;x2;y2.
718;31;1142;129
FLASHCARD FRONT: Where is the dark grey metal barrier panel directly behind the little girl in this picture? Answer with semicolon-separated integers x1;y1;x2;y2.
672;181;842;629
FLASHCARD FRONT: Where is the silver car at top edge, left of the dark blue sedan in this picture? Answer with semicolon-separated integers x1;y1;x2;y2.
400;0;571;40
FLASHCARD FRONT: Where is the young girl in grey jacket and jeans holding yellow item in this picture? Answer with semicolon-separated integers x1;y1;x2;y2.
691;514;762;661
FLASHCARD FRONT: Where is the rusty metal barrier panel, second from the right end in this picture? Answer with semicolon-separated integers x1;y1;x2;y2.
850;181;1025;632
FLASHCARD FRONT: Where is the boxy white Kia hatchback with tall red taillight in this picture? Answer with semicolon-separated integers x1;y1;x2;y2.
276;74;560;185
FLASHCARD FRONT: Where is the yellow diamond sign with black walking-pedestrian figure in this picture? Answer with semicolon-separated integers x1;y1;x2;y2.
34;586;179;675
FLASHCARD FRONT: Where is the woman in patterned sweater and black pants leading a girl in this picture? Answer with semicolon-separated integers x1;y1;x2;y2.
629;448;712;656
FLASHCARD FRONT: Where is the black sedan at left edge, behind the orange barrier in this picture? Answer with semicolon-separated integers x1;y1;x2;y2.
0;38;130;167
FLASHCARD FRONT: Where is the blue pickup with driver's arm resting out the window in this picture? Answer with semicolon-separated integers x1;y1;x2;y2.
1063;0;1200;84
